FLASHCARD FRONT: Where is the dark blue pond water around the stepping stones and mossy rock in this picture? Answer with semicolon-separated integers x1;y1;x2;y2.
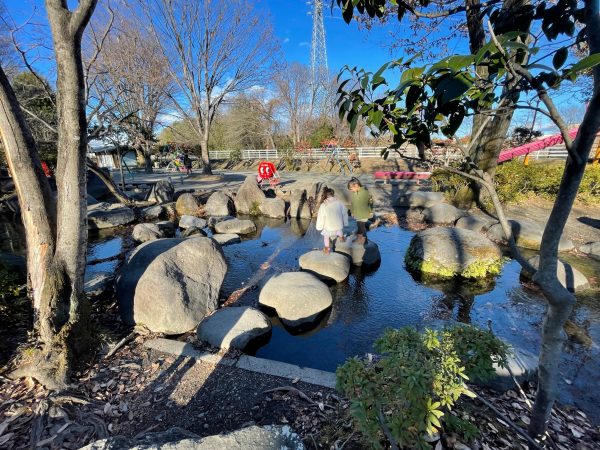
216;216;600;423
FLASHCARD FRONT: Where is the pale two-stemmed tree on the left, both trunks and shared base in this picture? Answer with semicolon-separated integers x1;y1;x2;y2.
0;0;97;388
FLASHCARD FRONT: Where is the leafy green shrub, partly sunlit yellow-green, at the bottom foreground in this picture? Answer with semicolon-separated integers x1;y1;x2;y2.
337;325;506;449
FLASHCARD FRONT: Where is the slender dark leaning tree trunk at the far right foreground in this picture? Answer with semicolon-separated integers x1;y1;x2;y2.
529;0;600;437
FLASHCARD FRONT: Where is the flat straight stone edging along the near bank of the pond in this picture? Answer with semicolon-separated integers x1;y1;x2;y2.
144;338;336;389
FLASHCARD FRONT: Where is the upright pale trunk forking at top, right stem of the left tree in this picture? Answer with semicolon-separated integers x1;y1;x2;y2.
19;0;96;388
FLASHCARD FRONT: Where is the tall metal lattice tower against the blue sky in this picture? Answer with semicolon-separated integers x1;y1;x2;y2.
310;0;330;115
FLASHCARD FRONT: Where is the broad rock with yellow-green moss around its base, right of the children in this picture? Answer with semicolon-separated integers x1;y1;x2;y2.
405;227;504;278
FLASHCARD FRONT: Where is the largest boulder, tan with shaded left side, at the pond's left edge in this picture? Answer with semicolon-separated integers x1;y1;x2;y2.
117;237;227;334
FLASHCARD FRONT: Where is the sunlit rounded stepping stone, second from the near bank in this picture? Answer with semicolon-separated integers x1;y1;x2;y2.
258;272;333;328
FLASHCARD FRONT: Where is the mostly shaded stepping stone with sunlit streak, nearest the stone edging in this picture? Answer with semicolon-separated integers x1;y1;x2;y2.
196;306;271;350
